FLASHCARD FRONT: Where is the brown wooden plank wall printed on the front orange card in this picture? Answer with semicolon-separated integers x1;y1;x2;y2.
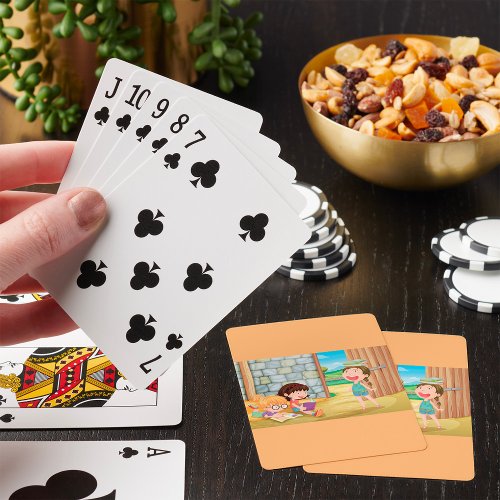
345;346;404;397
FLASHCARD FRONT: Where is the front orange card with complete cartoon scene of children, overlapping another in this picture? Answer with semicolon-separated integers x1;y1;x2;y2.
227;314;425;469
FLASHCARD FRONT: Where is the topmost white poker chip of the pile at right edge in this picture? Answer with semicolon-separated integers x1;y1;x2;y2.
460;217;500;258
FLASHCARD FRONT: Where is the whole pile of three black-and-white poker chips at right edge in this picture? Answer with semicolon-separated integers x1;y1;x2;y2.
431;217;500;314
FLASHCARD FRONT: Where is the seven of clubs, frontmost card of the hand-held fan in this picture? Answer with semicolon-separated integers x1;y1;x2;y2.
33;110;310;388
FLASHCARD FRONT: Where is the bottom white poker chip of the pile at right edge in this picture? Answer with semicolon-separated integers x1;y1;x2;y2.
443;267;500;314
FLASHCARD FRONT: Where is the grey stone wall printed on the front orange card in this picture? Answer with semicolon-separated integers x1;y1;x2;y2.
235;354;329;400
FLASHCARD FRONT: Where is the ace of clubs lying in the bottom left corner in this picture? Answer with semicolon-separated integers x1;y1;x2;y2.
0;440;186;500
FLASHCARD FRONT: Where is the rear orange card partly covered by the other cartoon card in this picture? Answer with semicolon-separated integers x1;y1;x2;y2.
304;332;474;481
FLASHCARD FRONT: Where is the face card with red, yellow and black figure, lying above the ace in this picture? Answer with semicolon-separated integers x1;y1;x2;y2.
0;294;182;429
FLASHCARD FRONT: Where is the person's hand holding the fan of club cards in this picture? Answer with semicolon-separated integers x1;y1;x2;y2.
0;141;106;345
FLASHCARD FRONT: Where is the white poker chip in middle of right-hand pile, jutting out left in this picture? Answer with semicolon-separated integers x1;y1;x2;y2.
431;229;500;271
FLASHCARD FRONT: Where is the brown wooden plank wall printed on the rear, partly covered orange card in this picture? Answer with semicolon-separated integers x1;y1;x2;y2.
425;366;471;418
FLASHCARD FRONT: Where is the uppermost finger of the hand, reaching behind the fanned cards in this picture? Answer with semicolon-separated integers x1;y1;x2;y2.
0;141;75;190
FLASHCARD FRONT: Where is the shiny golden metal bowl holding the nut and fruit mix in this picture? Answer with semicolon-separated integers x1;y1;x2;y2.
299;34;500;190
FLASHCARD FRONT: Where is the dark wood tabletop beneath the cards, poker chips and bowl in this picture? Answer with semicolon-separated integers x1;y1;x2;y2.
0;0;500;500
